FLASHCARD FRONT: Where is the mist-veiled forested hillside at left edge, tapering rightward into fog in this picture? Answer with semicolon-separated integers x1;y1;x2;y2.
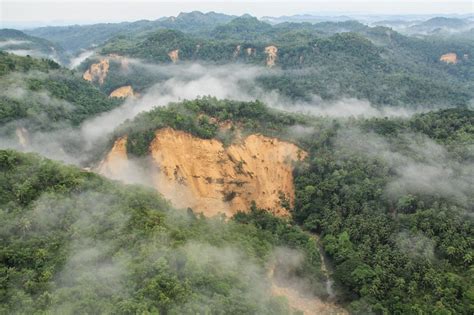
0;52;121;133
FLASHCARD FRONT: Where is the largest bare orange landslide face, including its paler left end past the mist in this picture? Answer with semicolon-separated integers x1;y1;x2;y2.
99;128;306;216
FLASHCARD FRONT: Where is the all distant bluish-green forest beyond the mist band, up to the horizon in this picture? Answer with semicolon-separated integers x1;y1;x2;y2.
19;12;474;108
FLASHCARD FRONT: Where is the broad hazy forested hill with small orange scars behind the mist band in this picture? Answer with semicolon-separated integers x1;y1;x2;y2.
81;17;474;107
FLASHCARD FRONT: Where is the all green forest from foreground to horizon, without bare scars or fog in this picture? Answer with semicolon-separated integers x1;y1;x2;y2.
0;12;474;314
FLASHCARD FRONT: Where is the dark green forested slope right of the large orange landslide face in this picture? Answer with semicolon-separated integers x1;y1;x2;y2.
294;110;474;314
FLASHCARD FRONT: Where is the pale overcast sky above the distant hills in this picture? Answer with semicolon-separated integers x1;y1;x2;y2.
0;0;474;25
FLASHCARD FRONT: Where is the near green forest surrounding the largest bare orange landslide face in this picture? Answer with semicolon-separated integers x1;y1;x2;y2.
0;98;474;314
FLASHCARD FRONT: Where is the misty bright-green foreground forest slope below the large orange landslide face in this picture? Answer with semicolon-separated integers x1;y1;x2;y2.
0;151;325;314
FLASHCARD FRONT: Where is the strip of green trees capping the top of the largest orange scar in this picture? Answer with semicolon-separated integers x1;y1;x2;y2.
112;97;303;156
